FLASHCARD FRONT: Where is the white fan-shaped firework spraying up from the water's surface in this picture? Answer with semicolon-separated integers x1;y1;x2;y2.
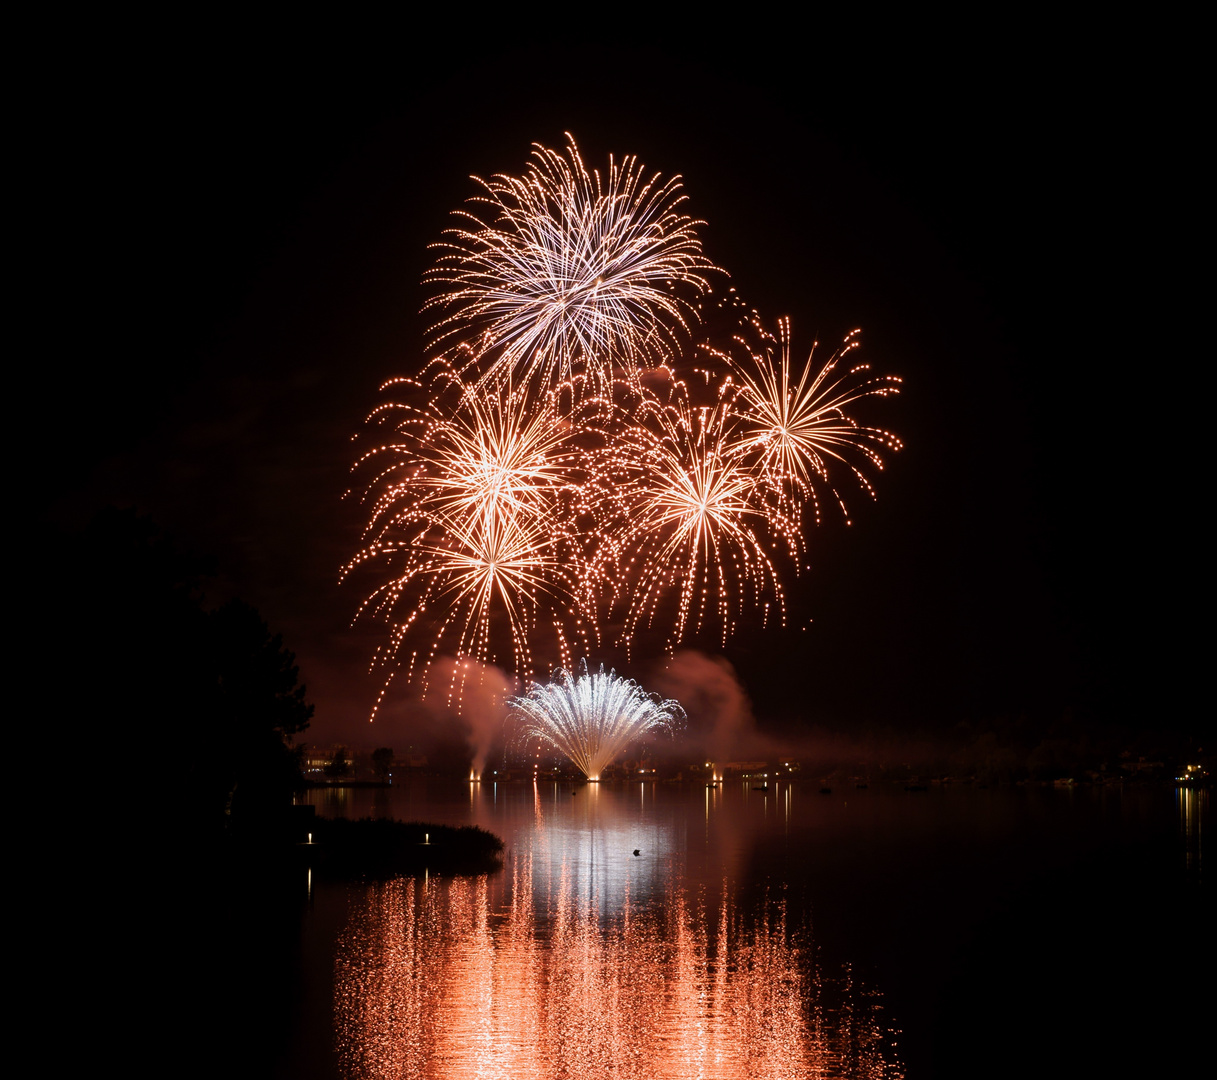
507;660;685;780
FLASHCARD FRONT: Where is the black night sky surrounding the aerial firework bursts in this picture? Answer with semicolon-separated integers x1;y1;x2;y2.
45;27;1202;743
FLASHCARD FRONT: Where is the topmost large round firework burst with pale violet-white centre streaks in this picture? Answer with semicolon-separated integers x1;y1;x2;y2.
427;134;714;388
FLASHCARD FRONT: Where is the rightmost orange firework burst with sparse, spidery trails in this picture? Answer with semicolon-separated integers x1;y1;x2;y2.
731;319;901;521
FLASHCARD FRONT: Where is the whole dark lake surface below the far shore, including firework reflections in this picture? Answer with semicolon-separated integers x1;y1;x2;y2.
171;779;1212;1080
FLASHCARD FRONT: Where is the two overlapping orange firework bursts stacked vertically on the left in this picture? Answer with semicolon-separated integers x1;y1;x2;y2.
343;366;593;701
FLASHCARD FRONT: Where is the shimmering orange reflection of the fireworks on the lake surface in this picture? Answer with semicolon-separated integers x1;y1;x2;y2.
335;847;903;1080
